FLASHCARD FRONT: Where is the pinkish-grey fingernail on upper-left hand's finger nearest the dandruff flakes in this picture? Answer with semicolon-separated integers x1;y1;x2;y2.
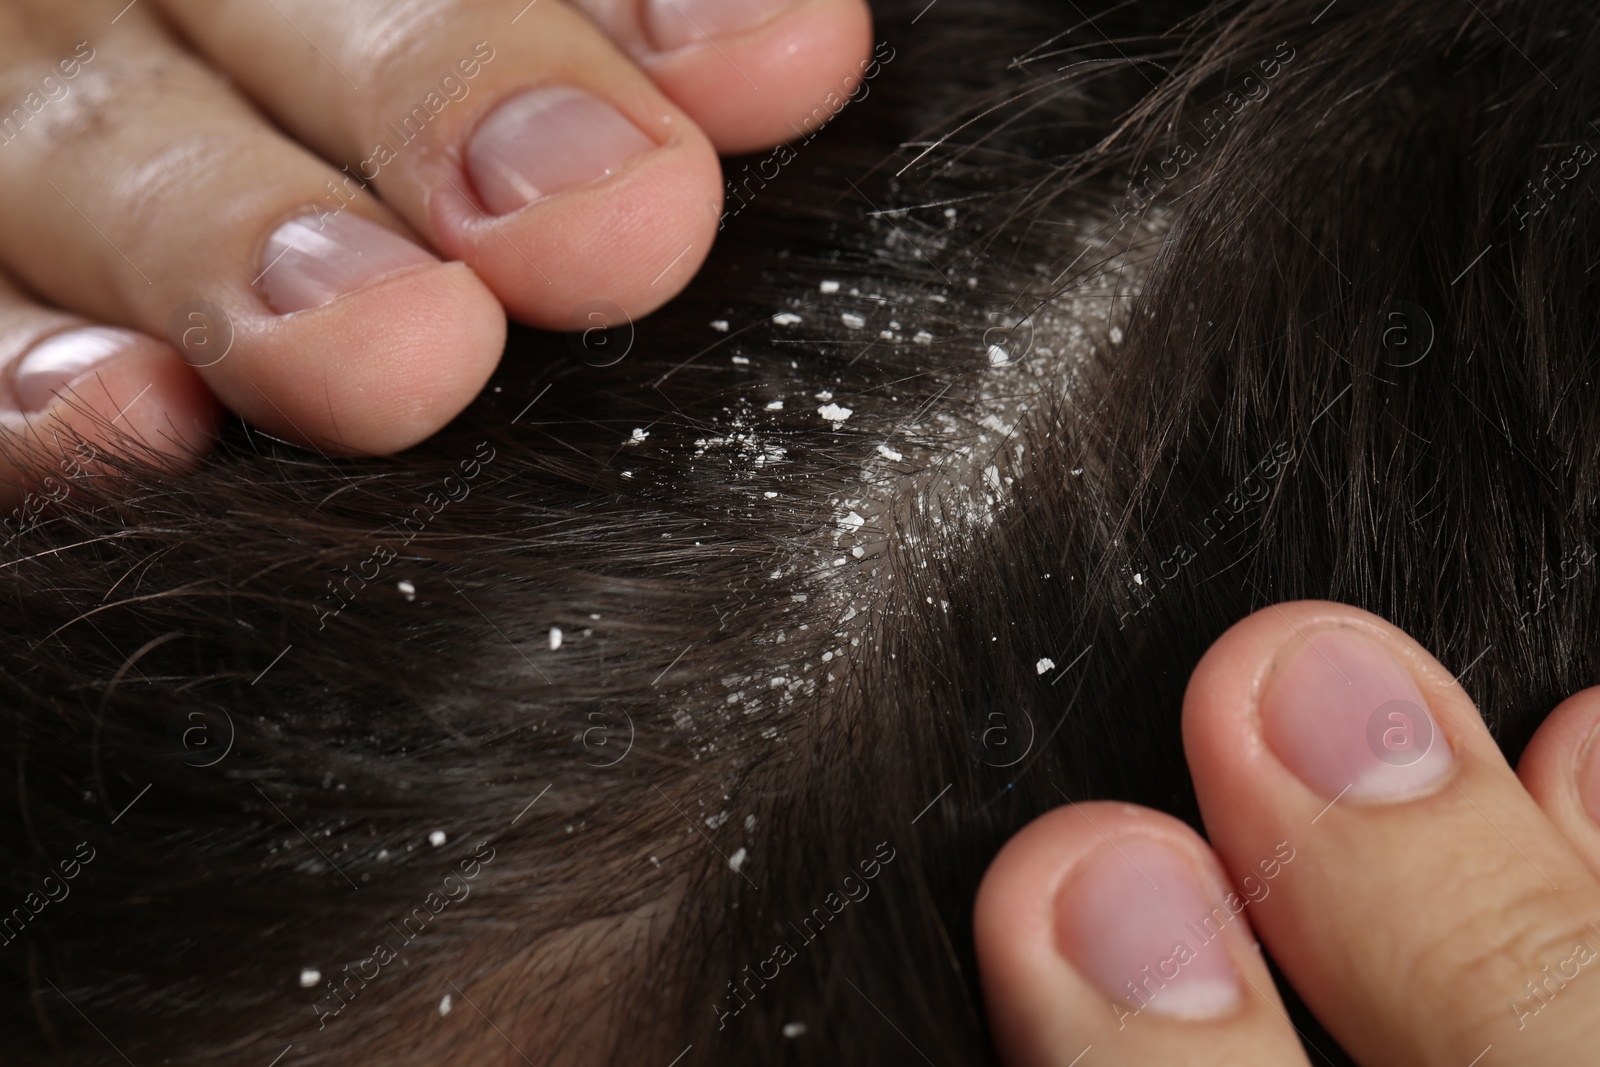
467;85;656;214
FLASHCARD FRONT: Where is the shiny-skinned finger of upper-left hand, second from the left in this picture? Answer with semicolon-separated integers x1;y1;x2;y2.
0;10;506;453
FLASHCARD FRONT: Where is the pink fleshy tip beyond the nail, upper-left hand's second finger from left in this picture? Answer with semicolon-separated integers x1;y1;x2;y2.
222;262;506;454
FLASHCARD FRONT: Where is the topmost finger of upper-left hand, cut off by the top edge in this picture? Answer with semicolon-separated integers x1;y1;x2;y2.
576;0;894;155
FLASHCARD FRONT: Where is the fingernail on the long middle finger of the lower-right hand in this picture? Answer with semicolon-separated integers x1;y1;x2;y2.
1261;629;1456;800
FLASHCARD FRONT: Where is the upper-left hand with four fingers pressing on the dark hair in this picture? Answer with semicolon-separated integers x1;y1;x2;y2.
0;0;870;504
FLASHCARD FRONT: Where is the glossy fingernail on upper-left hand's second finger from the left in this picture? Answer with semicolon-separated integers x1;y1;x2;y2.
256;211;438;315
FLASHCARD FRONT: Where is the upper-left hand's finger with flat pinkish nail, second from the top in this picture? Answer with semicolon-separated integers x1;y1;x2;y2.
156;0;722;330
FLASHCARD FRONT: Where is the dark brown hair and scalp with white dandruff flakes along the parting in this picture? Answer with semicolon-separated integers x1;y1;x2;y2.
0;0;1600;1067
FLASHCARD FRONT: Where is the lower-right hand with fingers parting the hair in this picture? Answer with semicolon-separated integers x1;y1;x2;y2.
974;601;1600;1067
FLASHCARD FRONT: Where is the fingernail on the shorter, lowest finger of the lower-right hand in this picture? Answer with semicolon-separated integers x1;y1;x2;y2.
1056;838;1243;1019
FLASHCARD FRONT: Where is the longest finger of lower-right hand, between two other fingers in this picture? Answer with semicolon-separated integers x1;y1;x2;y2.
1184;601;1600;1067
